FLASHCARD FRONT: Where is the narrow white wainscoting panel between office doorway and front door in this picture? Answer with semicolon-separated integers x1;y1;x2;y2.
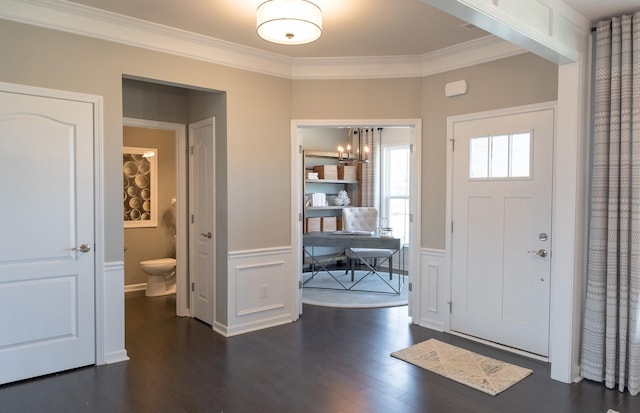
418;248;451;331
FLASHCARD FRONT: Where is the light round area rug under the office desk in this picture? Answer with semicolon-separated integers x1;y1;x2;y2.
302;270;408;308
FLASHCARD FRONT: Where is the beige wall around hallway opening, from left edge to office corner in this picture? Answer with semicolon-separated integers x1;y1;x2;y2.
0;20;291;262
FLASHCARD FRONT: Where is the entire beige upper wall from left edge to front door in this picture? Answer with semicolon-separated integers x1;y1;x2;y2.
0;20;557;323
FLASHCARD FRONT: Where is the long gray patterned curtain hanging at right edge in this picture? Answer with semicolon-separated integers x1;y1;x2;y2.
581;12;640;395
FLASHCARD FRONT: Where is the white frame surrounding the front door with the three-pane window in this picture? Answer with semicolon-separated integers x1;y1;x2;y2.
448;101;559;352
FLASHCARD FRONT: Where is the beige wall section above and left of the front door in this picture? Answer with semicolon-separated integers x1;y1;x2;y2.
421;54;558;249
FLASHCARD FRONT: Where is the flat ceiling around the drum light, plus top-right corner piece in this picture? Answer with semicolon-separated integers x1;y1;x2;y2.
63;0;638;58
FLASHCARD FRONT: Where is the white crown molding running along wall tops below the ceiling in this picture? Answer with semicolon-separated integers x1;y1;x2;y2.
0;0;525;79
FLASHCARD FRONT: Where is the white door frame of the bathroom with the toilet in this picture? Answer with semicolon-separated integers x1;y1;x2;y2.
122;118;191;317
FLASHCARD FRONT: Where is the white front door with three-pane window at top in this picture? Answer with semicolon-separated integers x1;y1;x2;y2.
451;109;554;356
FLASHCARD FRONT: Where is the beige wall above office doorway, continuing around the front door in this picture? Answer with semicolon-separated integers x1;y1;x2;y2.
292;54;558;249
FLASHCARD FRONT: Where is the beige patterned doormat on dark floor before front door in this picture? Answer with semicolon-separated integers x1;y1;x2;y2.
391;338;533;396
